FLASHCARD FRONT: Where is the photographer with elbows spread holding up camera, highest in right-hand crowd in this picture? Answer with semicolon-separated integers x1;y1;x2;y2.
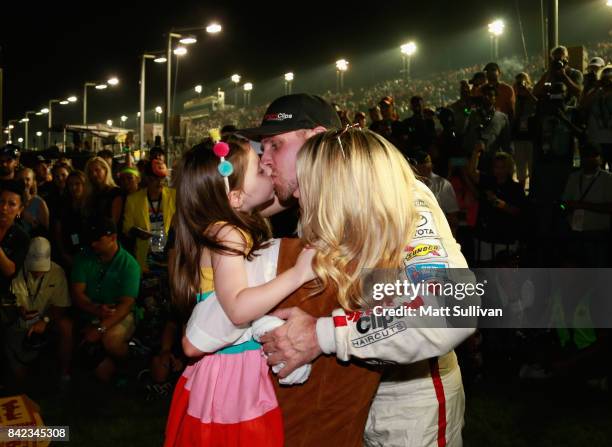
533;46;583;107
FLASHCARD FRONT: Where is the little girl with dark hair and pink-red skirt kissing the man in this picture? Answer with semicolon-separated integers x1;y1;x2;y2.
164;140;314;447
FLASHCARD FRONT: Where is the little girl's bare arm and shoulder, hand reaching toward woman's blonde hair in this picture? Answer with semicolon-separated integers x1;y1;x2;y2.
211;227;314;325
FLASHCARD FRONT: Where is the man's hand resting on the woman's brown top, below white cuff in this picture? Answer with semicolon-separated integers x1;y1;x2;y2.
261;307;321;379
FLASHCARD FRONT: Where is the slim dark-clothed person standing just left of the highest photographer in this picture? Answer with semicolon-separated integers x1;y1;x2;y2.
512;72;538;188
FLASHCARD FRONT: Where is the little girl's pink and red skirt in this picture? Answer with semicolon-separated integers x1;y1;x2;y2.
164;349;284;447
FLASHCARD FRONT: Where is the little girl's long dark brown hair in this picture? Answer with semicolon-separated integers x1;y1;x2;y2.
170;140;271;310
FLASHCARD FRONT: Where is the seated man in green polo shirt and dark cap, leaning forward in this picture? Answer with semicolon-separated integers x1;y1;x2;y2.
71;219;140;381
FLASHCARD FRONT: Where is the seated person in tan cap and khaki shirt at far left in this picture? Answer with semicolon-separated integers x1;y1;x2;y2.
7;237;72;383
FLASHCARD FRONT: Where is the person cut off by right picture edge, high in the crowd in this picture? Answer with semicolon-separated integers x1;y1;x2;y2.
580;66;612;171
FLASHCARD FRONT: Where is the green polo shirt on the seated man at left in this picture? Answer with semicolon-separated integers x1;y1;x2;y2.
71;246;140;304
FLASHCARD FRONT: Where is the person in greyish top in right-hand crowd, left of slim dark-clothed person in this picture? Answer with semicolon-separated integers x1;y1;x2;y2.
463;85;512;173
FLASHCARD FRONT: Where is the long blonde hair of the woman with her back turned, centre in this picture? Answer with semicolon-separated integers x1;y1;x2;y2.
297;129;431;310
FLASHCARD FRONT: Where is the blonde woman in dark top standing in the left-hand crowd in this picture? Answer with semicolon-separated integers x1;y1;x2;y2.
85;157;121;218
